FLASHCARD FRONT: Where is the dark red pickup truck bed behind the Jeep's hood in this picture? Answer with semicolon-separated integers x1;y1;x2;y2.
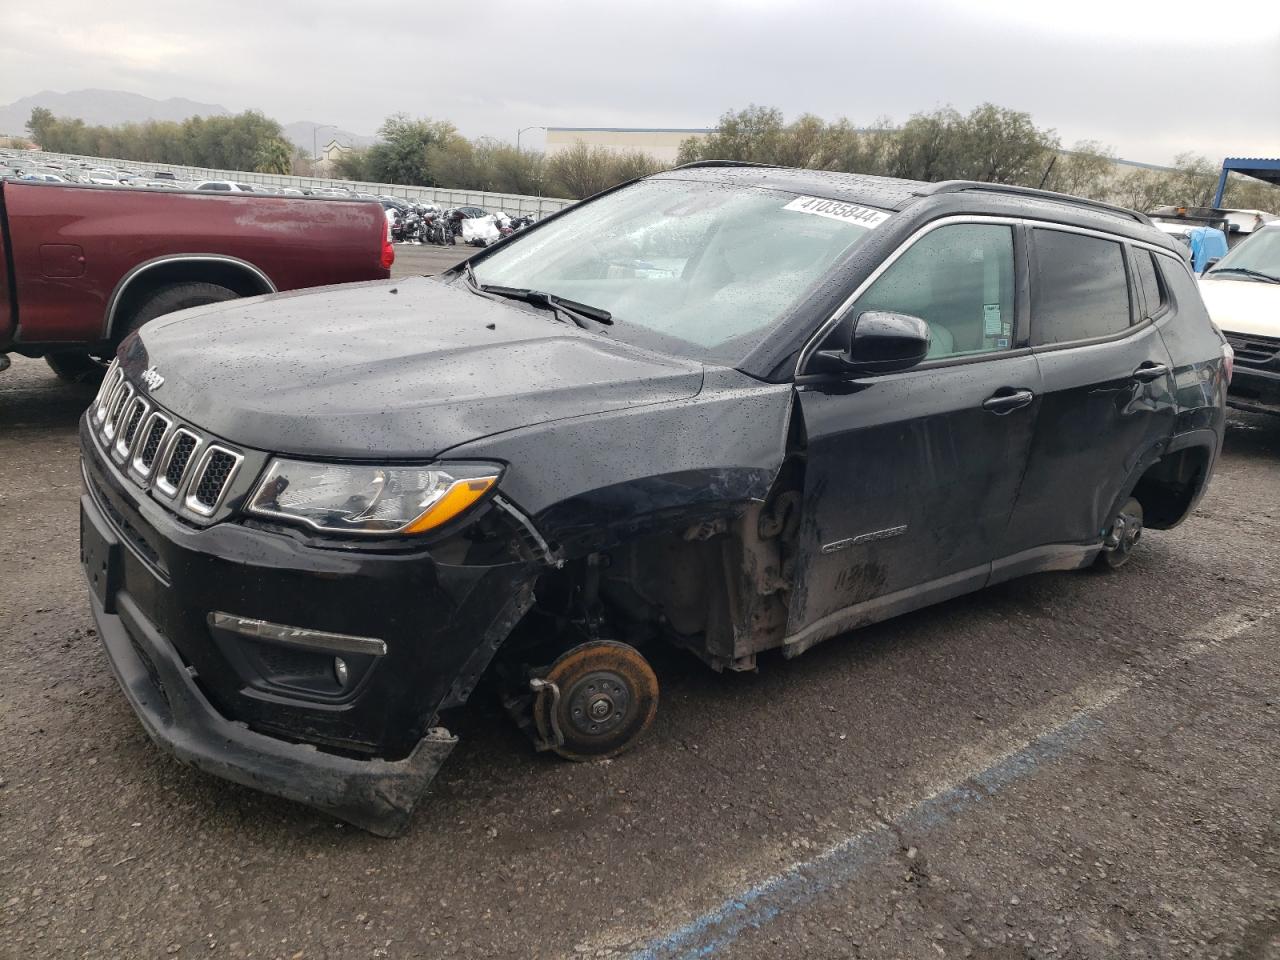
0;180;396;380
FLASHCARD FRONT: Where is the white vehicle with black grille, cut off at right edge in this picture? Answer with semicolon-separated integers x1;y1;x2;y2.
1199;224;1280;416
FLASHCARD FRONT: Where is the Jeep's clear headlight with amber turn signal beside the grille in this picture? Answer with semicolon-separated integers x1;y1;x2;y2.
241;458;502;534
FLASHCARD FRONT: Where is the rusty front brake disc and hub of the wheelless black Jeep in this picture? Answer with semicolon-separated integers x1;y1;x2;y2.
534;640;658;760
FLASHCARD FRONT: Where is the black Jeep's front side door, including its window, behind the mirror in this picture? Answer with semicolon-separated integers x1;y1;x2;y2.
787;219;1041;653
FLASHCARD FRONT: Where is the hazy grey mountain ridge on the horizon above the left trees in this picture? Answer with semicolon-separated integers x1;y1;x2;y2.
0;90;376;155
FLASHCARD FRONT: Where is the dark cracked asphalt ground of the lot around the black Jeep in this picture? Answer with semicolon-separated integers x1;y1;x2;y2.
0;257;1280;960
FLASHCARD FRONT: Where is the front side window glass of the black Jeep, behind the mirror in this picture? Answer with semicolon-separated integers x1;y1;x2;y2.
852;224;1014;360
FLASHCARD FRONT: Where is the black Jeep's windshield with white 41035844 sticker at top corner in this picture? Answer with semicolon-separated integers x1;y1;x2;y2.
475;180;890;364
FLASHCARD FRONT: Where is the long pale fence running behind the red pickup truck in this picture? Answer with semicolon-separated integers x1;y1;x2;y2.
13;151;575;218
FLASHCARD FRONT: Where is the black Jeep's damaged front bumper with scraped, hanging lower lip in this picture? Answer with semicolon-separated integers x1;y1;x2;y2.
81;421;536;836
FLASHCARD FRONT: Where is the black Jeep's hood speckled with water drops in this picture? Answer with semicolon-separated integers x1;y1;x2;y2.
120;278;703;458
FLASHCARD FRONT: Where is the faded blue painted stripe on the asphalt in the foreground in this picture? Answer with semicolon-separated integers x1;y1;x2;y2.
628;710;1101;960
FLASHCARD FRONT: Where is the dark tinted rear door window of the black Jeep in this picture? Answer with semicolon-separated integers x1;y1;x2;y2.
1032;230;1129;343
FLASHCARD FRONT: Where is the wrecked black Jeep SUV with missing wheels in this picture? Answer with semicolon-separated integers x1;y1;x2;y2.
81;163;1231;835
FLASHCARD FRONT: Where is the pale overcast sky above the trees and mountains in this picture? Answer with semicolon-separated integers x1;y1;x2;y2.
0;0;1280;163
